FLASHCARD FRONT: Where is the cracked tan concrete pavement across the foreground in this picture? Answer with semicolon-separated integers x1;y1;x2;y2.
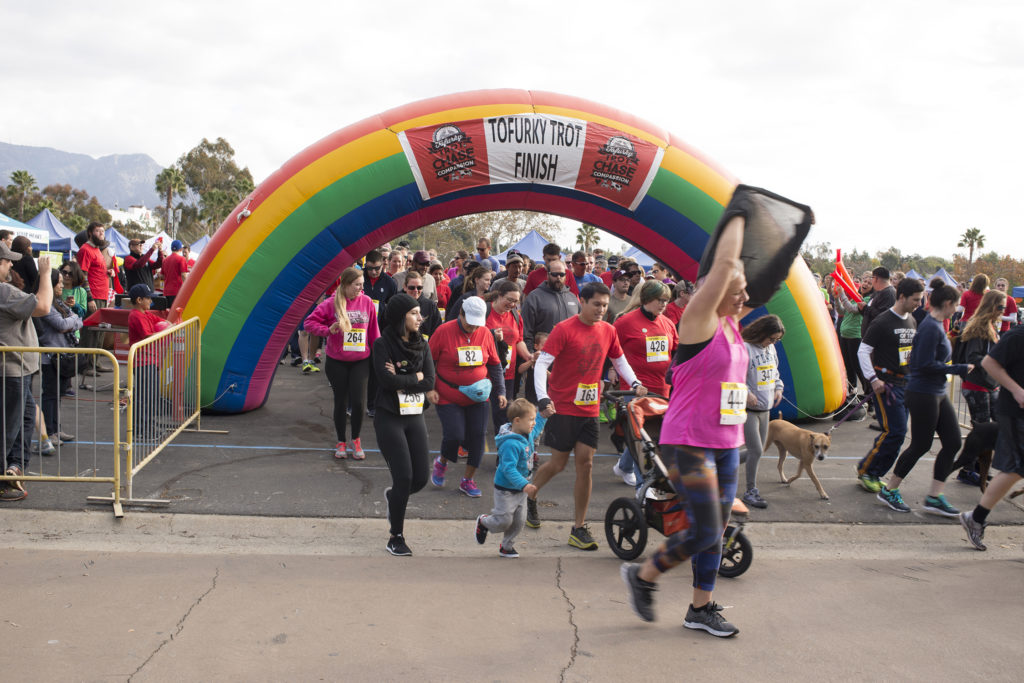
0;511;1024;681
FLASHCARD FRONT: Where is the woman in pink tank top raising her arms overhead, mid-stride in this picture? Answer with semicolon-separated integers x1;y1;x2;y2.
622;215;749;637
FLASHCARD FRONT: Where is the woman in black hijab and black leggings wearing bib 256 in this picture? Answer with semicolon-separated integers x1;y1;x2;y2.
371;294;434;556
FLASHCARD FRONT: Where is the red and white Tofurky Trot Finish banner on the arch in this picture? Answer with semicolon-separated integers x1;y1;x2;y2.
398;113;665;211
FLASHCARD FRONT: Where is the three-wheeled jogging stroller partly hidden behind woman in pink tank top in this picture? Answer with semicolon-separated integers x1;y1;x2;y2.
604;391;754;579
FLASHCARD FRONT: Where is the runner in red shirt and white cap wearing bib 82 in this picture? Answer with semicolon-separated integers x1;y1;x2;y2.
427;297;506;498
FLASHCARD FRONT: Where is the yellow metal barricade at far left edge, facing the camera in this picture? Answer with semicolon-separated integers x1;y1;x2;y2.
0;346;124;517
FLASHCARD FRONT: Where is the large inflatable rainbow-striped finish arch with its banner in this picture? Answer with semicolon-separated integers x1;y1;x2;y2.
175;90;846;417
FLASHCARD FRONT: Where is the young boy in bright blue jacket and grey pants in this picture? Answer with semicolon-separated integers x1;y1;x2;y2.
476;398;547;557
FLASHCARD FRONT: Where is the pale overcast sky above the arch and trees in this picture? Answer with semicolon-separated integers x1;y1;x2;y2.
0;0;1024;258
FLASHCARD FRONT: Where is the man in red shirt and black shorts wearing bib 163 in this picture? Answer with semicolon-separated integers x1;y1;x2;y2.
526;283;647;550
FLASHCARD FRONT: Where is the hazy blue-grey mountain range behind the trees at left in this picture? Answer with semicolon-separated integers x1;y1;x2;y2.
0;142;164;209
